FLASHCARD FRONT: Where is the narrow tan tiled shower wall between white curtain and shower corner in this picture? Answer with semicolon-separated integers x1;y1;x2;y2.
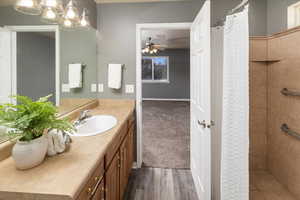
249;38;267;170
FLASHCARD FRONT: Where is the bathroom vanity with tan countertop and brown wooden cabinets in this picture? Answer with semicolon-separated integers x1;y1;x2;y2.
0;100;135;200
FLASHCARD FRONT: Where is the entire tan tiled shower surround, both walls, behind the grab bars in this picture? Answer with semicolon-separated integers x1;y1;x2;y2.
250;28;300;199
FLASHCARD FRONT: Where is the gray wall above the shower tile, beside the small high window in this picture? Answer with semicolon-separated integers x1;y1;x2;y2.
267;0;299;35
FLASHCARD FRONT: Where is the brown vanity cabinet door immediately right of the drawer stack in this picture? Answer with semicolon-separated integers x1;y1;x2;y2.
105;151;120;200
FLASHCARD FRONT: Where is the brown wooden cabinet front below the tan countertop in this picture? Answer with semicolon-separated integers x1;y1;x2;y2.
76;114;135;200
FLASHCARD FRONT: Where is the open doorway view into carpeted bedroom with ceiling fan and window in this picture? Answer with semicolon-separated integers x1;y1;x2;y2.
141;29;190;169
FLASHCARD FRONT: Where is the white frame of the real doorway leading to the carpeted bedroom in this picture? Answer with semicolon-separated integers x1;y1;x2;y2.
135;22;192;168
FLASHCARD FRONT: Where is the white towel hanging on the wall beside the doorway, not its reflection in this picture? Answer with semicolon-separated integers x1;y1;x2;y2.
108;64;122;89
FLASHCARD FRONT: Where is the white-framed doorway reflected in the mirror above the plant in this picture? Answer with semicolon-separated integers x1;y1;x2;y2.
5;25;60;106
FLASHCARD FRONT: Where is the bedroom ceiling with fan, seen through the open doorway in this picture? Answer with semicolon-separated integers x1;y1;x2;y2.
142;29;190;49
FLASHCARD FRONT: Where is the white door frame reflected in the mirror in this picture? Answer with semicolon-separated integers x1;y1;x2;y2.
5;25;60;106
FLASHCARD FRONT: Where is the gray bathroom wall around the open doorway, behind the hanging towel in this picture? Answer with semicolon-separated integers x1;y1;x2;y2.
97;0;266;98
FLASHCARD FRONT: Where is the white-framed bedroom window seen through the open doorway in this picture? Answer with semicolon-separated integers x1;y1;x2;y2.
142;56;169;83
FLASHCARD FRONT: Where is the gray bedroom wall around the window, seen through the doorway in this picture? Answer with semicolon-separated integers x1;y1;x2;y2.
143;49;190;99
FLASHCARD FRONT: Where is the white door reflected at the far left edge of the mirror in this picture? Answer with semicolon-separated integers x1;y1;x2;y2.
0;28;12;104
